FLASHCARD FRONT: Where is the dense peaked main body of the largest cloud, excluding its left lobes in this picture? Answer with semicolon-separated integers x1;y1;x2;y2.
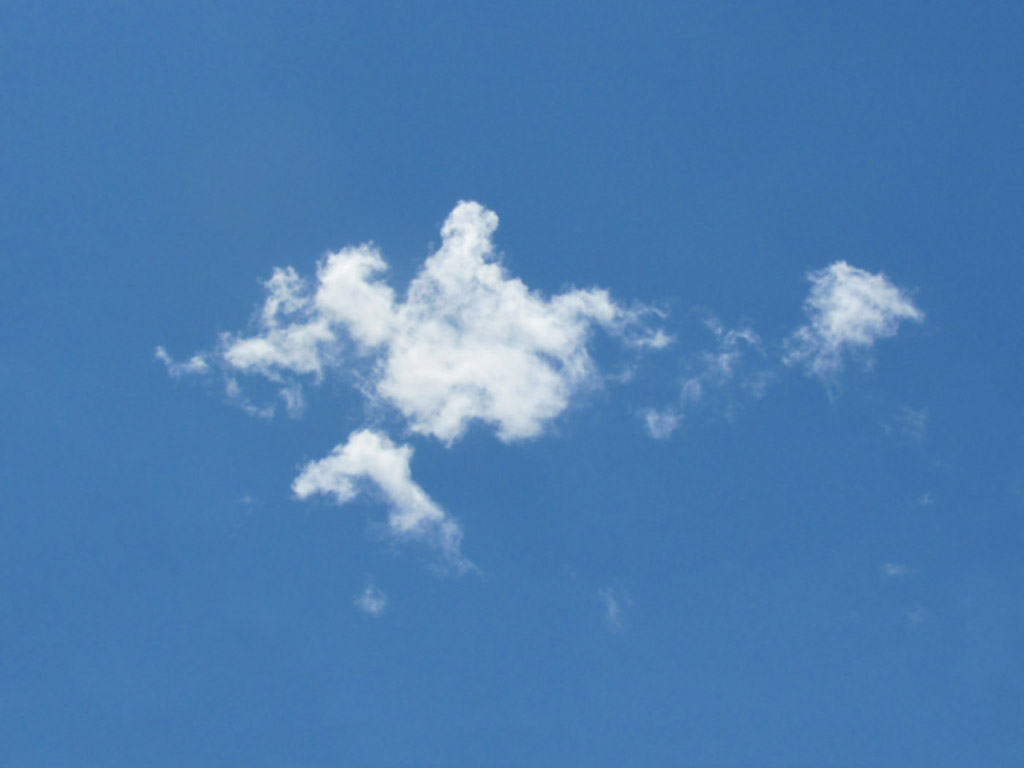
367;203;664;443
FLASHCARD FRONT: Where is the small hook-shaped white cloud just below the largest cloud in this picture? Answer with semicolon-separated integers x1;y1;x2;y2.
292;429;472;570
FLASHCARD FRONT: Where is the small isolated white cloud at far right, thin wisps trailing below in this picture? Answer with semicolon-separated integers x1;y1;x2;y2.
782;261;925;377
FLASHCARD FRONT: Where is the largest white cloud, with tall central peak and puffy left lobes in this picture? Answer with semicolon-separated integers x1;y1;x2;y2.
209;202;672;443
